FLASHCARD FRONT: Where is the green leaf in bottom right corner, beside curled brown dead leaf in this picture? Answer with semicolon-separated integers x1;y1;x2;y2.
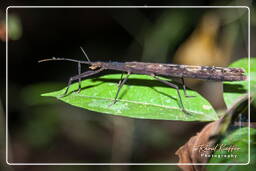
207;127;256;171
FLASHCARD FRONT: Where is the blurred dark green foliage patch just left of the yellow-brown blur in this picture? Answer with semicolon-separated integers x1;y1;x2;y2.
142;9;194;62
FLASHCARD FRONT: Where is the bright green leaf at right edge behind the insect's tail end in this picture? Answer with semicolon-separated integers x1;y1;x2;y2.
223;58;256;107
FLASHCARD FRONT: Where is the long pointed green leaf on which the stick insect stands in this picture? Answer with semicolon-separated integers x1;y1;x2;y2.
43;74;218;121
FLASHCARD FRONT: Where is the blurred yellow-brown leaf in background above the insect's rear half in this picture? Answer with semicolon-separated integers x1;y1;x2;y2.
174;12;230;66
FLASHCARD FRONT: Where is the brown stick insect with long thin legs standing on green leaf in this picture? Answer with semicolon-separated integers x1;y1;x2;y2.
38;47;246;113
